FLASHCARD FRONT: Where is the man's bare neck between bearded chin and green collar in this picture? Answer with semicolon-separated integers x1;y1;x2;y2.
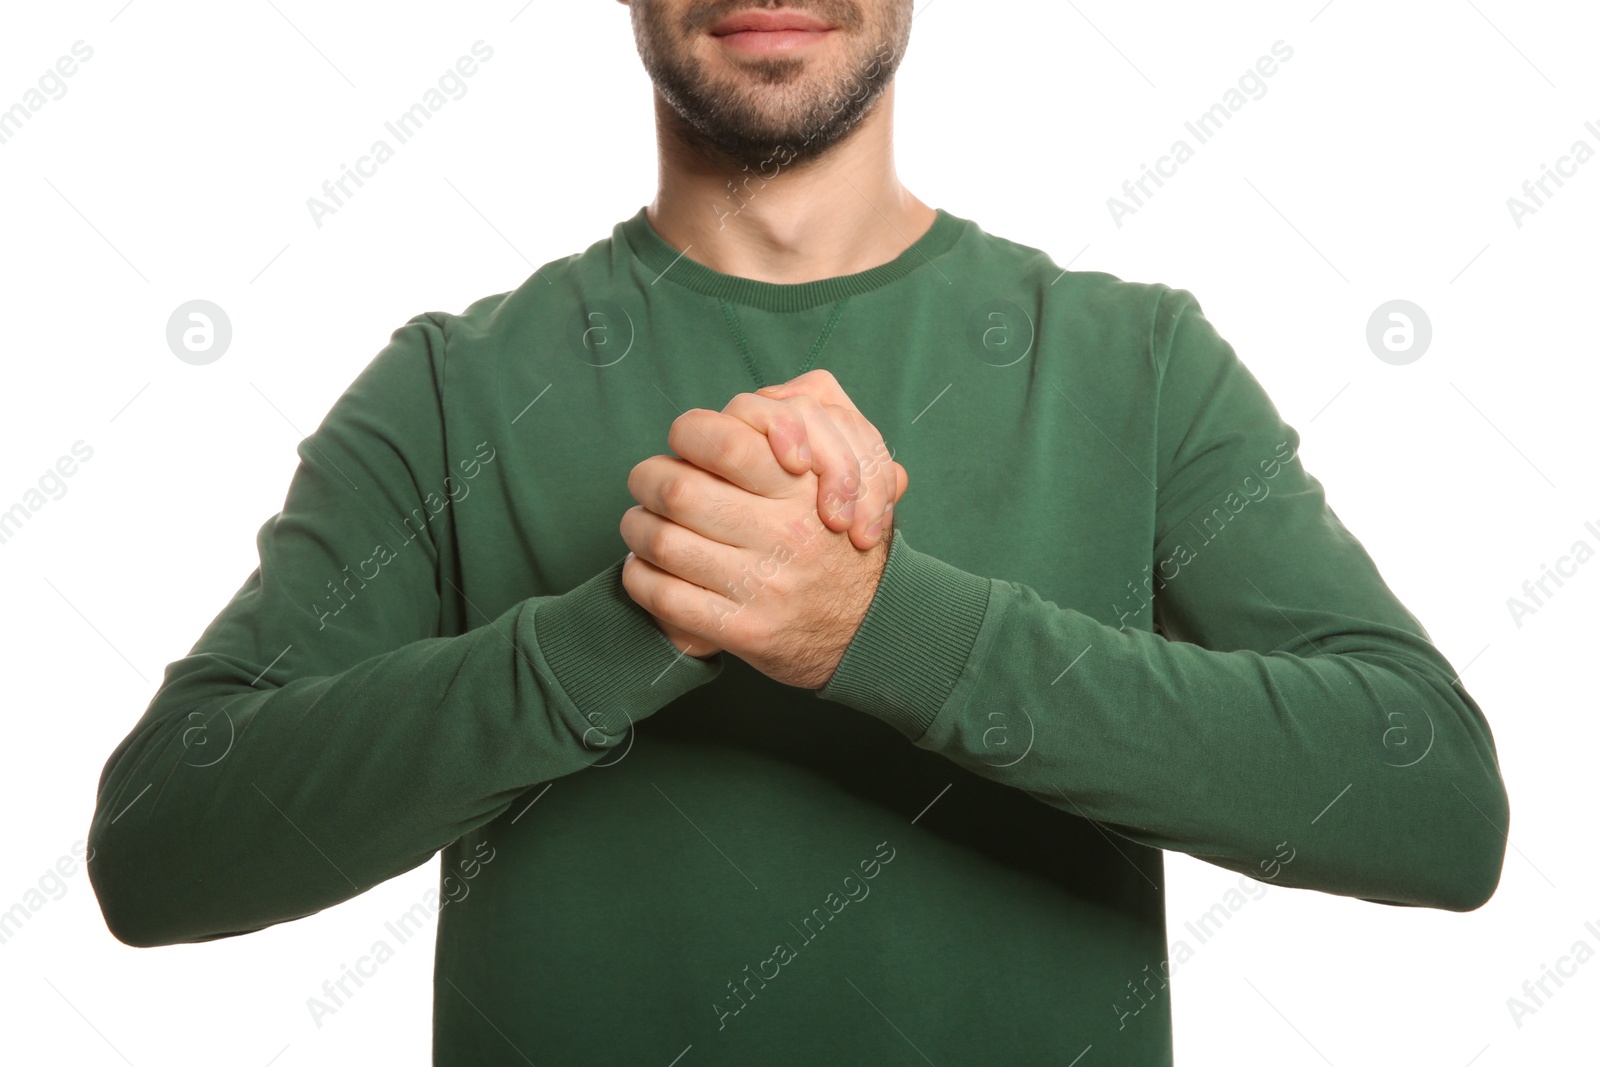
646;83;934;283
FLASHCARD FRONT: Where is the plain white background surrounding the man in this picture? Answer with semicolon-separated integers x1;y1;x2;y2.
0;0;1600;1067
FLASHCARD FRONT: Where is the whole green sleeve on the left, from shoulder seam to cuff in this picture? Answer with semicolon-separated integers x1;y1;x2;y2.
90;315;722;945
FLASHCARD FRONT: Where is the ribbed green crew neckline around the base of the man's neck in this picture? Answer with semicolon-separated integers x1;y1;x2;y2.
618;206;968;312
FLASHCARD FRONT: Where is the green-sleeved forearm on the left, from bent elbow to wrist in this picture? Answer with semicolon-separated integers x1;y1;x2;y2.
90;563;722;945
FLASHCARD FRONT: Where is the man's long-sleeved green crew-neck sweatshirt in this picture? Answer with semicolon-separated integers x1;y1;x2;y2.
90;210;1509;1067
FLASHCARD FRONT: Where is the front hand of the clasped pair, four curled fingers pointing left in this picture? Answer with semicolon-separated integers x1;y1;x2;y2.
621;408;890;689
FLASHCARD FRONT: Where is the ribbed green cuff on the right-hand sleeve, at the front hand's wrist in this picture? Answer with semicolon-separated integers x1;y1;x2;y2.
816;530;989;741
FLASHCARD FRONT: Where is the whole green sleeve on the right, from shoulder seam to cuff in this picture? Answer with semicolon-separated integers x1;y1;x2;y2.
818;290;1509;910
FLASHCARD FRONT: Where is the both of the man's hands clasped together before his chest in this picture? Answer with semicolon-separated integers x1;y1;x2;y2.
621;370;909;689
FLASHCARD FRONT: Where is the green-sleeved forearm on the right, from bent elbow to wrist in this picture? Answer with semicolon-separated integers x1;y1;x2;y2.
819;534;1507;910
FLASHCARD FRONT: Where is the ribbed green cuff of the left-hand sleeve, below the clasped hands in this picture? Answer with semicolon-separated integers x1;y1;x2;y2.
533;557;722;736
